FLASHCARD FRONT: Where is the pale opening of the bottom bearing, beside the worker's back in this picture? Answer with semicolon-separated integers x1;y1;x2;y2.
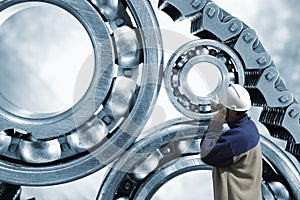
151;170;213;200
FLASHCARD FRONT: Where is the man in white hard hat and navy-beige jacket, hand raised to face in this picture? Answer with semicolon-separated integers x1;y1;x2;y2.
201;84;262;200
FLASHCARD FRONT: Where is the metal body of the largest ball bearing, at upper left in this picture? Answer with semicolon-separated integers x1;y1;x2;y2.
0;0;162;186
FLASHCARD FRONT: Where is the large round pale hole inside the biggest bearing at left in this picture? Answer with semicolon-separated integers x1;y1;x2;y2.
0;2;95;118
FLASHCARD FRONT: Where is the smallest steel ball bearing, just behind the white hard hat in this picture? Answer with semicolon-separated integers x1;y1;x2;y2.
164;39;244;119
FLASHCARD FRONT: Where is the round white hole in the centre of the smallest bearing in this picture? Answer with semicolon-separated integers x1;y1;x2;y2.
187;62;222;97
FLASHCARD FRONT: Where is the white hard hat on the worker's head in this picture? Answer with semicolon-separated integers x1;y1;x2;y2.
220;84;251;111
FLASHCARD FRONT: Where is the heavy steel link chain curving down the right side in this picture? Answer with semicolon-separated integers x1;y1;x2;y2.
159;0;300;161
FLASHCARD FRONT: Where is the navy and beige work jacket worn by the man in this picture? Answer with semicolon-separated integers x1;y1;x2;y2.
201;115;262;200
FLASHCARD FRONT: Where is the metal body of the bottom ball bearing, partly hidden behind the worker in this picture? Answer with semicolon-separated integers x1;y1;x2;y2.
98;119;300;200
